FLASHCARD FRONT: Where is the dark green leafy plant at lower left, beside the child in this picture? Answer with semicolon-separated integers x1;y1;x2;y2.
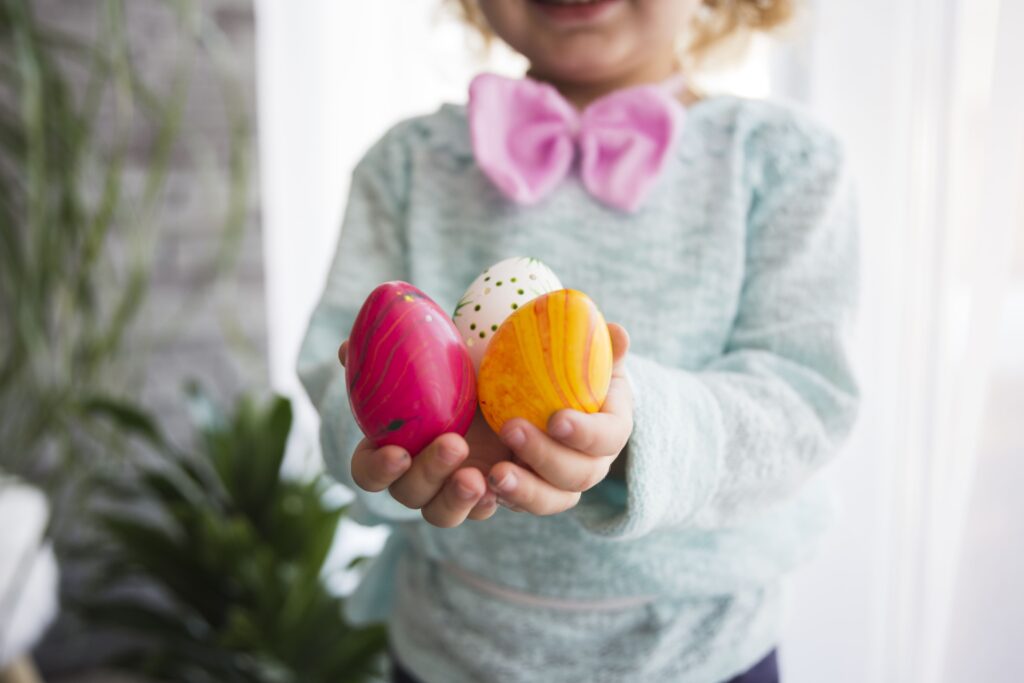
82;391;386;683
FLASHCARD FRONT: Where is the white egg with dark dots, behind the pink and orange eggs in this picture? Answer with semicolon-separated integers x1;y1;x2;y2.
452;257;562;370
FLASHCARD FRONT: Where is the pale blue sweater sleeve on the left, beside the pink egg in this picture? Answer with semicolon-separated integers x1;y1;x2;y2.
298;129;419;524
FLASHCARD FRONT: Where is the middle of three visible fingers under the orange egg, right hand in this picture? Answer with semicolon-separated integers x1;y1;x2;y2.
492;419;613;493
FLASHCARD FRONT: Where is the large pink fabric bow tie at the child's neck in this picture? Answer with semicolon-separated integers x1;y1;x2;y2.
468;74;686;211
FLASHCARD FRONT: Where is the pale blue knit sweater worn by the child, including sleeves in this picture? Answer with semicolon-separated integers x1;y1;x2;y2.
299;97;857;683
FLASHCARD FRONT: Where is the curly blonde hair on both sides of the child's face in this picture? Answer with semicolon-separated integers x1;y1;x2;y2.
446;0;798;70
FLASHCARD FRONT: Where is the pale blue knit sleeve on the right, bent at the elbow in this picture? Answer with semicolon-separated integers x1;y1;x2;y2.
574;121;858;538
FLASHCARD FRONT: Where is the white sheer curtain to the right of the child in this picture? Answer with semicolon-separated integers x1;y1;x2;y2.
779;0;1024;682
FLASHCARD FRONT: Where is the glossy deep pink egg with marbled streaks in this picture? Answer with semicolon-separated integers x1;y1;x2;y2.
345;282;476;456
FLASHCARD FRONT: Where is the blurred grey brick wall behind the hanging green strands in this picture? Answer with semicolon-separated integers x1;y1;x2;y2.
40;0;266;433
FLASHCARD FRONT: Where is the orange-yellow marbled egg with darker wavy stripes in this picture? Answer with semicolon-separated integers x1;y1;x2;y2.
477;290;612;432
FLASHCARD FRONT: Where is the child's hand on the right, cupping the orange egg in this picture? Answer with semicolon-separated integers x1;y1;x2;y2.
487;324;633;515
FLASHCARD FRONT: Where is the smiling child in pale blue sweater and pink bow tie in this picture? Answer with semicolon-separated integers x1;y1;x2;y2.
300;0;857;683
